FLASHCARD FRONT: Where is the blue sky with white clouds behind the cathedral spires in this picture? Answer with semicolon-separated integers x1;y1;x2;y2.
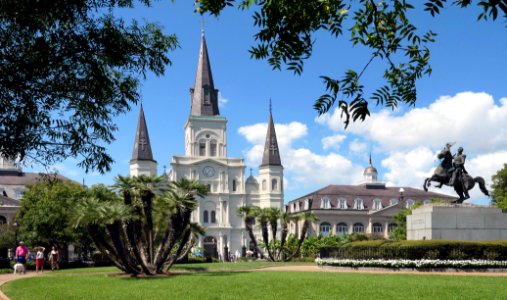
29;1;507;203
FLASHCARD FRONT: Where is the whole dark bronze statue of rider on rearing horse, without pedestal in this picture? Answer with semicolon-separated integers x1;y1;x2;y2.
424;143;489;203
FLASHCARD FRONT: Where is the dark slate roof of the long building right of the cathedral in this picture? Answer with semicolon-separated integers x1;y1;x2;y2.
289;184;456;210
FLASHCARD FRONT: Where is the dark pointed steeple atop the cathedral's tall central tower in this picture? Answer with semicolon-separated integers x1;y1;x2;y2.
190;31;220;116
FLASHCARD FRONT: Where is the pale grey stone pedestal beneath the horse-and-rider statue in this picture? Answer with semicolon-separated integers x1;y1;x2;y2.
407;204;507;241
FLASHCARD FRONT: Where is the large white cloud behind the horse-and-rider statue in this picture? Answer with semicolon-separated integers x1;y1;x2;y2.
316;92;507;203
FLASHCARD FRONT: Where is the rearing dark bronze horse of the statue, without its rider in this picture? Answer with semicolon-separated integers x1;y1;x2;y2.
424;149;489;203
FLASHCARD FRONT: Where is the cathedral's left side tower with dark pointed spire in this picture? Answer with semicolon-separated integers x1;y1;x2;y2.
130;104;157;177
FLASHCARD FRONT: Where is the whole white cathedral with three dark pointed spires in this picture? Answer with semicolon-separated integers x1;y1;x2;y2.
130;34;284;257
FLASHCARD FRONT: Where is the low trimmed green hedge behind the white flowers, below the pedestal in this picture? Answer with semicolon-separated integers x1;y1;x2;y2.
320;240;507;260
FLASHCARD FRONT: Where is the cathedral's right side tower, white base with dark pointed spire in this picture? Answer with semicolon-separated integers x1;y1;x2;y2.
259;103;283;209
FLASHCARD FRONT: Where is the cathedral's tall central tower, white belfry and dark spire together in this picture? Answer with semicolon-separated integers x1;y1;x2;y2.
185;33;227;158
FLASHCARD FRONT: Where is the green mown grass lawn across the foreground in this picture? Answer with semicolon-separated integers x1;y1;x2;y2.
2;263;507;300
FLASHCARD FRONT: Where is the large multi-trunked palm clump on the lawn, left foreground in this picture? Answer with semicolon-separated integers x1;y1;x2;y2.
74;176;207;275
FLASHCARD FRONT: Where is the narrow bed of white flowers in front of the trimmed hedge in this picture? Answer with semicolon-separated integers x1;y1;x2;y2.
315;258;507;269
